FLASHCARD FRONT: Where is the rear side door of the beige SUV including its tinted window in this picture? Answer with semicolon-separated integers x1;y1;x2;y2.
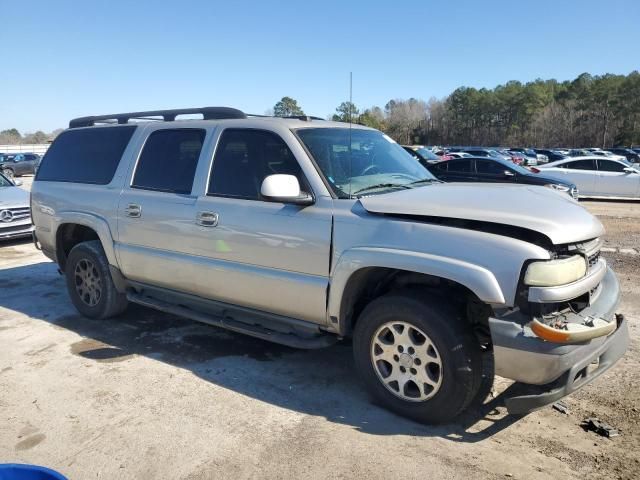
116;128;207;293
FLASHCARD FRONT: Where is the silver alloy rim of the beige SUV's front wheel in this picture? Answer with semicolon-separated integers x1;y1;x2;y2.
371;321;442;402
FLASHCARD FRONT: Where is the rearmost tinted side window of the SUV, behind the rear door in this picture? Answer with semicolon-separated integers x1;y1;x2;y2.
36;125;136;185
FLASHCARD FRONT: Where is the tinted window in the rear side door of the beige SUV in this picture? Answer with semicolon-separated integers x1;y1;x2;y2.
131;128;206;194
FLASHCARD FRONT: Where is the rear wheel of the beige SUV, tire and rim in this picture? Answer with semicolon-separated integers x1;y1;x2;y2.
65;240;128;319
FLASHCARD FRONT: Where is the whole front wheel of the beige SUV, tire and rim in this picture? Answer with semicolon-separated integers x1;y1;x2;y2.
353;294;482;423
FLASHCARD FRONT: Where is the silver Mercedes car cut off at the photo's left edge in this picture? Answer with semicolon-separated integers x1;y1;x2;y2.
0;174;33;240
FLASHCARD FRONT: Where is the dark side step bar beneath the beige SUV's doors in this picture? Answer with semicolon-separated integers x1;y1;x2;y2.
127;292;338;349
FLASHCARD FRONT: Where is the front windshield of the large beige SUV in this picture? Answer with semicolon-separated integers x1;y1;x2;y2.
296;128;436;198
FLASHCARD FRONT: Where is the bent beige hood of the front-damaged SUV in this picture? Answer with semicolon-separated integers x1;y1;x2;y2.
360;183;604;245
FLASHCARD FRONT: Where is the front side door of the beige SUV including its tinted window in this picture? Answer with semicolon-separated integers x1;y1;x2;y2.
190;129;332;323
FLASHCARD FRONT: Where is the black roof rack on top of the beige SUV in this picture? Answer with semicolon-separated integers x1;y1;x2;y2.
69;107;247;128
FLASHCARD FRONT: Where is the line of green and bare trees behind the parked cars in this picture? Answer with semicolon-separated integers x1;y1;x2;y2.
273;71;640;148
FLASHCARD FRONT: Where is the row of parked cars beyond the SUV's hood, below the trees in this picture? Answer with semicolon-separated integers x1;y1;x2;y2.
404;145;640;199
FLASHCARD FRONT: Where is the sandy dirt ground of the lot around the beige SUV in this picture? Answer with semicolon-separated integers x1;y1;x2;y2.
0;177;640;479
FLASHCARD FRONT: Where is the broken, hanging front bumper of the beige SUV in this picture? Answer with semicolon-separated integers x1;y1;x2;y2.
489;267;629;414
